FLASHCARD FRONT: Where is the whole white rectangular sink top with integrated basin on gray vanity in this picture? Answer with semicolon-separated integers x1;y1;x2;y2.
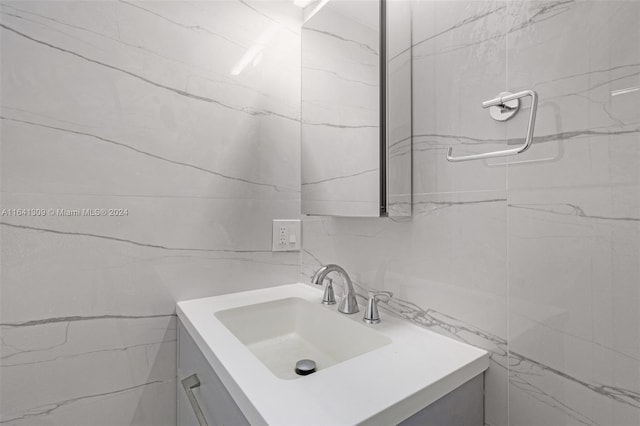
176;284;489;426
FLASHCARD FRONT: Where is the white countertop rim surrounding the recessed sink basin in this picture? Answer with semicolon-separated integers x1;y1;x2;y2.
177;284;489;426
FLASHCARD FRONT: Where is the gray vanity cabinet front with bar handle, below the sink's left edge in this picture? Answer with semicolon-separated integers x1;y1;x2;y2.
178;321;249;426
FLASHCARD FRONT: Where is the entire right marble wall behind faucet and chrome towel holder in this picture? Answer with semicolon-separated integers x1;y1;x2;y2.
302;0;640;426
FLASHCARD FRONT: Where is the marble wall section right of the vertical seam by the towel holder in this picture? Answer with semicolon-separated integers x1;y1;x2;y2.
506;1;640;425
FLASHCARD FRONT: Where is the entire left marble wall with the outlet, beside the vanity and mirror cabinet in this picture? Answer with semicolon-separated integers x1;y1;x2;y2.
0;0;301;426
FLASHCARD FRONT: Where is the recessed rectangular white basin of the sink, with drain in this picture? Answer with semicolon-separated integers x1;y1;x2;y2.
215;297;391;380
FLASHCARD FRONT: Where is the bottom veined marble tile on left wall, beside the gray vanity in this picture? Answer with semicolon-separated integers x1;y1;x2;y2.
0;315;176;425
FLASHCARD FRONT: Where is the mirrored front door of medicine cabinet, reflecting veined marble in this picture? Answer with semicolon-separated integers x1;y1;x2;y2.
301;0;380;217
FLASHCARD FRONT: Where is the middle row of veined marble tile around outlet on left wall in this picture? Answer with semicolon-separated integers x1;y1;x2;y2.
0;194;298;321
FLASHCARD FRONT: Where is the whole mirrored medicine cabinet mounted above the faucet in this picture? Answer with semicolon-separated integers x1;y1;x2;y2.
301;0;411;217
